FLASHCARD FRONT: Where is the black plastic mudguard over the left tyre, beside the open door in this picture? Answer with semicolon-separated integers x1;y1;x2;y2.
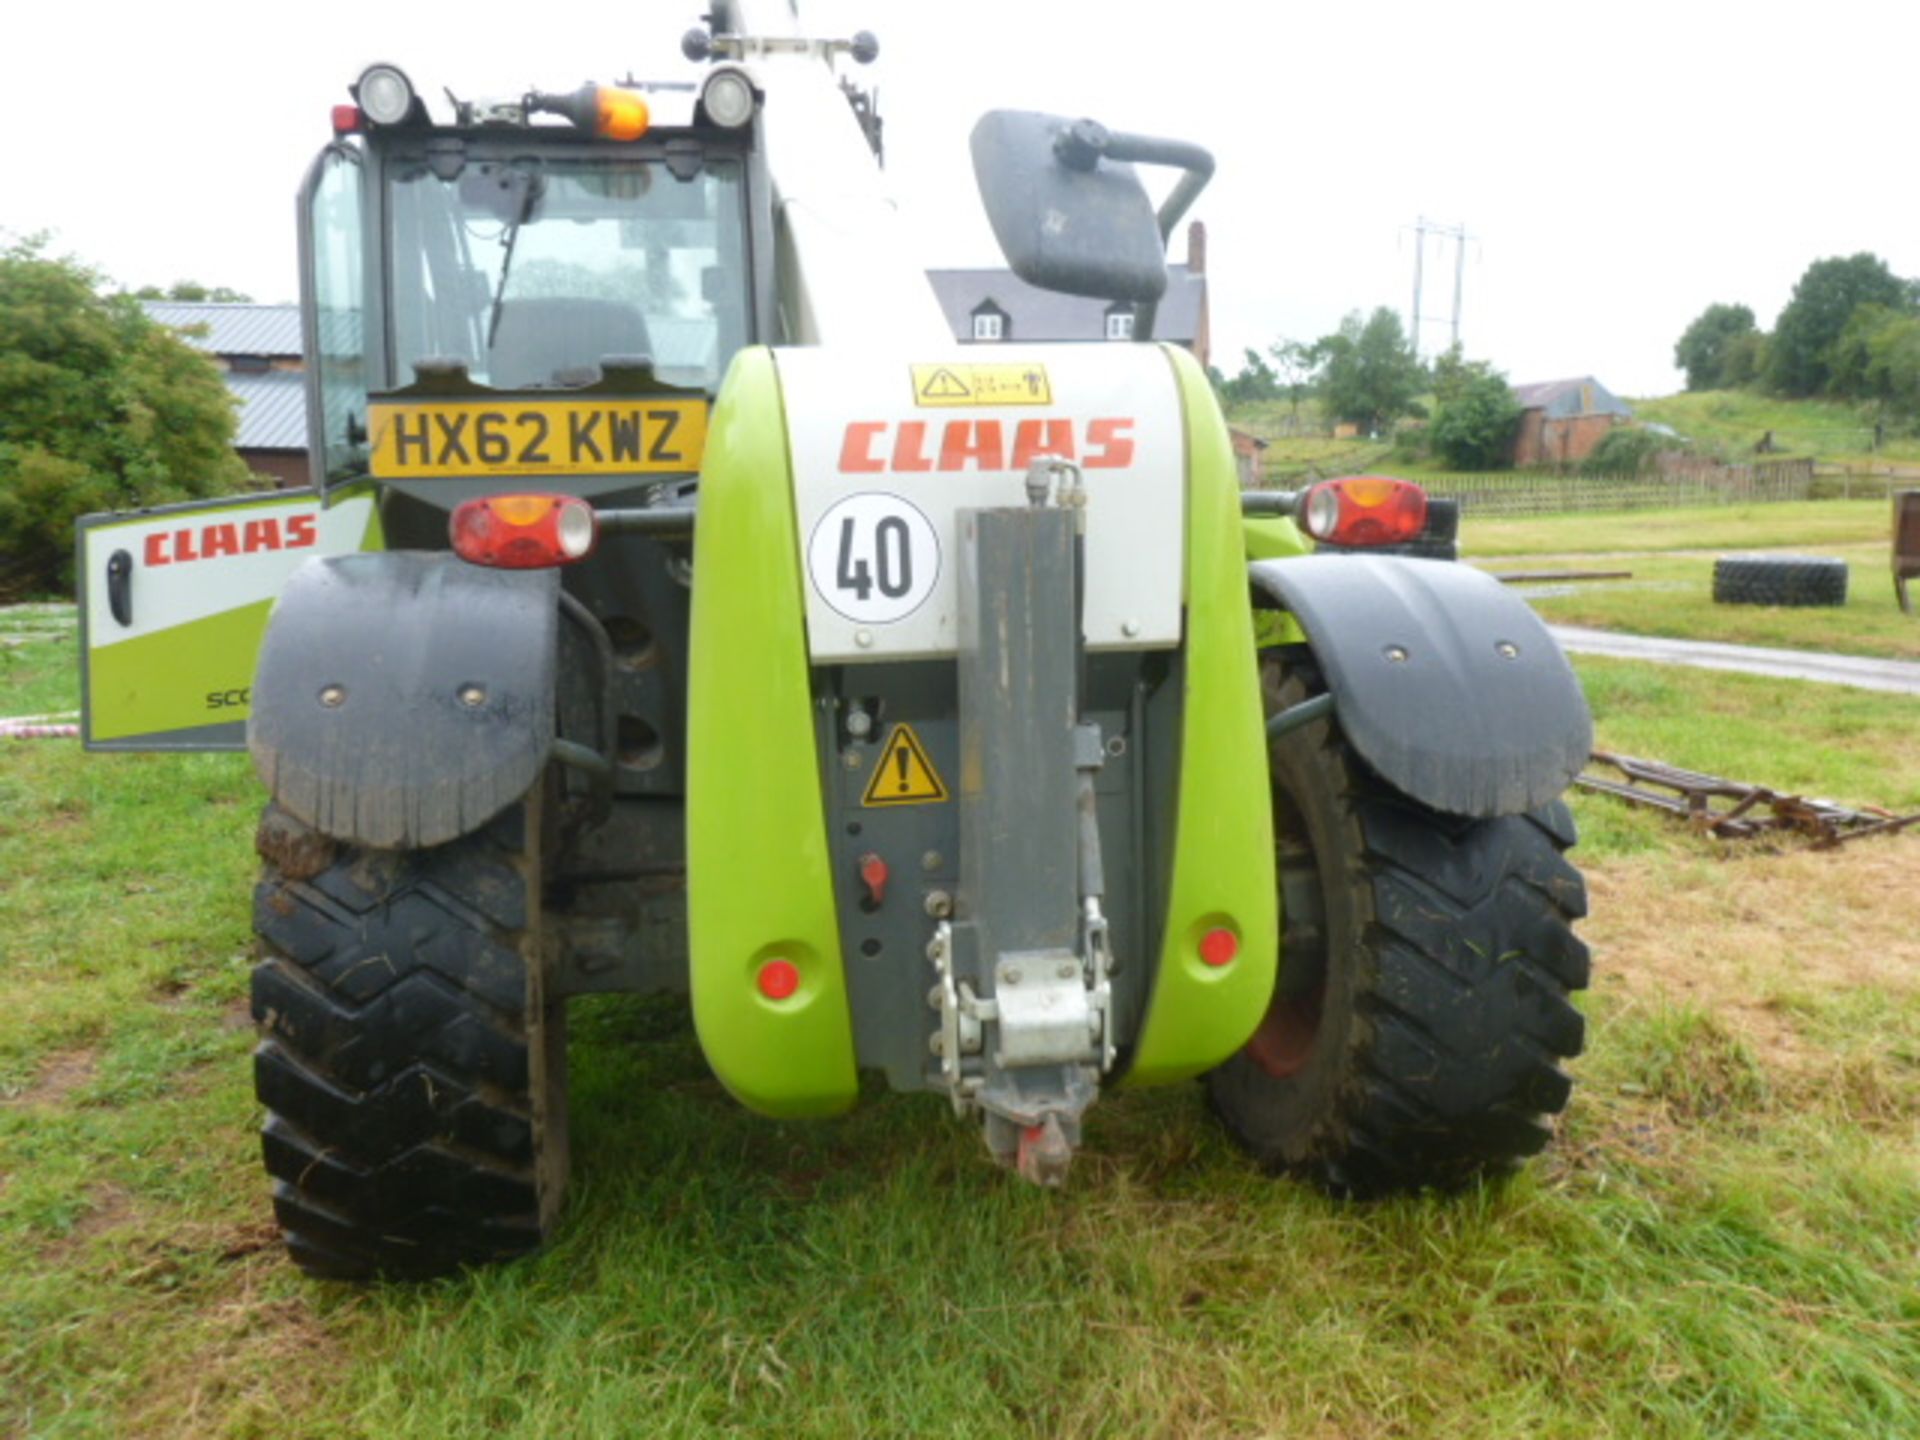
248;551;561;849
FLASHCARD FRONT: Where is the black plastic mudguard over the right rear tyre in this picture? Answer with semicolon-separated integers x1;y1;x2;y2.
1248;555;1594;818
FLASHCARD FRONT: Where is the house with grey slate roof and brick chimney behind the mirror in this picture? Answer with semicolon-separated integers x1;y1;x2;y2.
927;221;1212;365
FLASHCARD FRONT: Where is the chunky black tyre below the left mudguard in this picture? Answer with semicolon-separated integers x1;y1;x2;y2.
253;787;566;1281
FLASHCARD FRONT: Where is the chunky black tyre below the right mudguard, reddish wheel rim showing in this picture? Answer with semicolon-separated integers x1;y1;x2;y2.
1206;651;1588;1198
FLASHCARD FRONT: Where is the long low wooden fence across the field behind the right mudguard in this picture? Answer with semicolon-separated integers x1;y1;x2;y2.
1421;461;1812;516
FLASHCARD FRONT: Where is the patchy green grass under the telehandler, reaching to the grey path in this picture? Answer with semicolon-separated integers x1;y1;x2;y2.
0;579;1920;1440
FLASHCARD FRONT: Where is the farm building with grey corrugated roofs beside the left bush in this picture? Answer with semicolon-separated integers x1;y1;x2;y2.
142;300;307;490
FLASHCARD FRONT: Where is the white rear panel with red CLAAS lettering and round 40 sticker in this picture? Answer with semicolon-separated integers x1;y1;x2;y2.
776;344;1187;662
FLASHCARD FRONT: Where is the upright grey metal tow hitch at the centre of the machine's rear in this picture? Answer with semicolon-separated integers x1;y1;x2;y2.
927;459;1116;1187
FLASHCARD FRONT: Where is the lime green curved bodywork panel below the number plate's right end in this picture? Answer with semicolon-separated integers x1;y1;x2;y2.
687;349;858;1117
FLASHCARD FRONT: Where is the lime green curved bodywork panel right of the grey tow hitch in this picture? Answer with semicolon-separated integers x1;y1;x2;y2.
1127;348;1298;1085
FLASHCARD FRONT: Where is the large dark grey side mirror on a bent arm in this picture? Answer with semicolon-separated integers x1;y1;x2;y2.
972;109;1213;326
